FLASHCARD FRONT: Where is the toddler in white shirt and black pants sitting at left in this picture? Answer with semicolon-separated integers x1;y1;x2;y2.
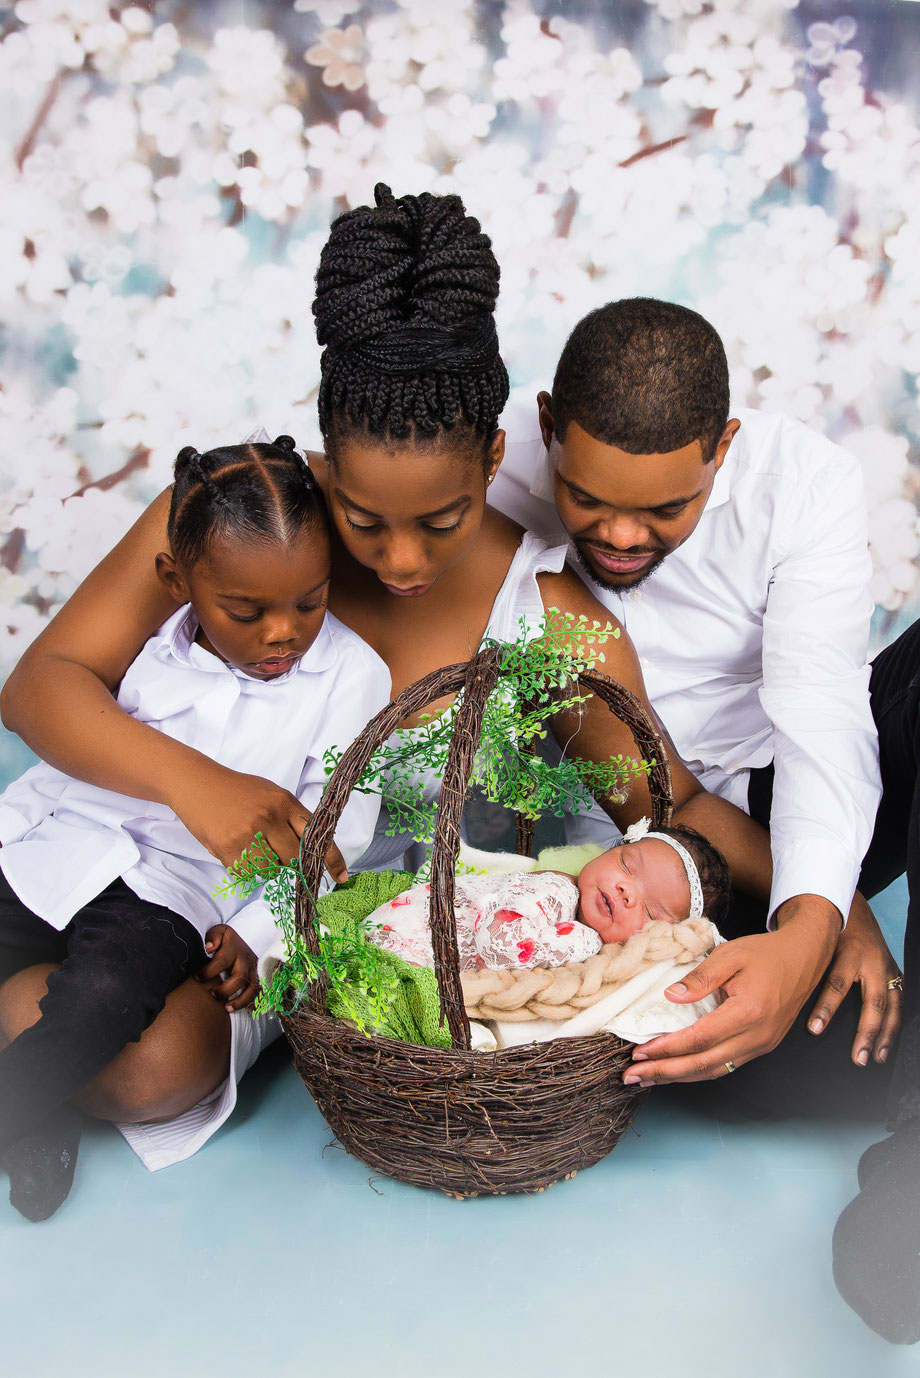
0;435;390;1220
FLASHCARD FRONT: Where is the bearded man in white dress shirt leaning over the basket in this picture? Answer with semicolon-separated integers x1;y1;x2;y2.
492;299;920;1339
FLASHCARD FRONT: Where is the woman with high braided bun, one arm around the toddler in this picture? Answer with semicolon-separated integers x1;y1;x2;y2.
0;187;770;1146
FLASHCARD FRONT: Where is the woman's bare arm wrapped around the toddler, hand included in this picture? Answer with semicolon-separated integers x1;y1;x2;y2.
0;493;344;878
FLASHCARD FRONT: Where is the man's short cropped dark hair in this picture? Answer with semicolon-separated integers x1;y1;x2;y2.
552;296;729;462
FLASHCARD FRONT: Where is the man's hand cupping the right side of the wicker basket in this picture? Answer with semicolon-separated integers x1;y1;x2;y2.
624;894;840;1086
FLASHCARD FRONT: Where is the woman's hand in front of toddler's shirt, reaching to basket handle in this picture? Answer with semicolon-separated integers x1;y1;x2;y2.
169;758;348;882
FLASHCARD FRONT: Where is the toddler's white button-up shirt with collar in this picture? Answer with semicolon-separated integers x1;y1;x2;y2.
0;605;390;954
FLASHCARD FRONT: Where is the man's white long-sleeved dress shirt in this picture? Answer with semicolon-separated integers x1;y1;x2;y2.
489;405;880;918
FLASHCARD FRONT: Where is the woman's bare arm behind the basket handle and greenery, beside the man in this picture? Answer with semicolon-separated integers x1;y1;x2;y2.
539;569;773;900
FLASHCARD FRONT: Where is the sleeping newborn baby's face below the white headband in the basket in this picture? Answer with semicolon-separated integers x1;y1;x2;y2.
576;838;690;943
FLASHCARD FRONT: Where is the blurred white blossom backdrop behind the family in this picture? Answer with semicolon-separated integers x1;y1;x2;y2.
0;0;920;774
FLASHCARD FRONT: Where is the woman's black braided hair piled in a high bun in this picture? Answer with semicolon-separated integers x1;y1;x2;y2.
313;183;508;451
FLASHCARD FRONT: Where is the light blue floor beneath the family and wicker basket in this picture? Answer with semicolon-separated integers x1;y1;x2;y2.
0;885;920;1378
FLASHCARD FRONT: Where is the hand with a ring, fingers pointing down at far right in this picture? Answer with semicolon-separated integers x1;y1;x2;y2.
808;890;901;1067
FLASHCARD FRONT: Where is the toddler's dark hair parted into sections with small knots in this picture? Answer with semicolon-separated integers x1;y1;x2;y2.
168;435;326;569
